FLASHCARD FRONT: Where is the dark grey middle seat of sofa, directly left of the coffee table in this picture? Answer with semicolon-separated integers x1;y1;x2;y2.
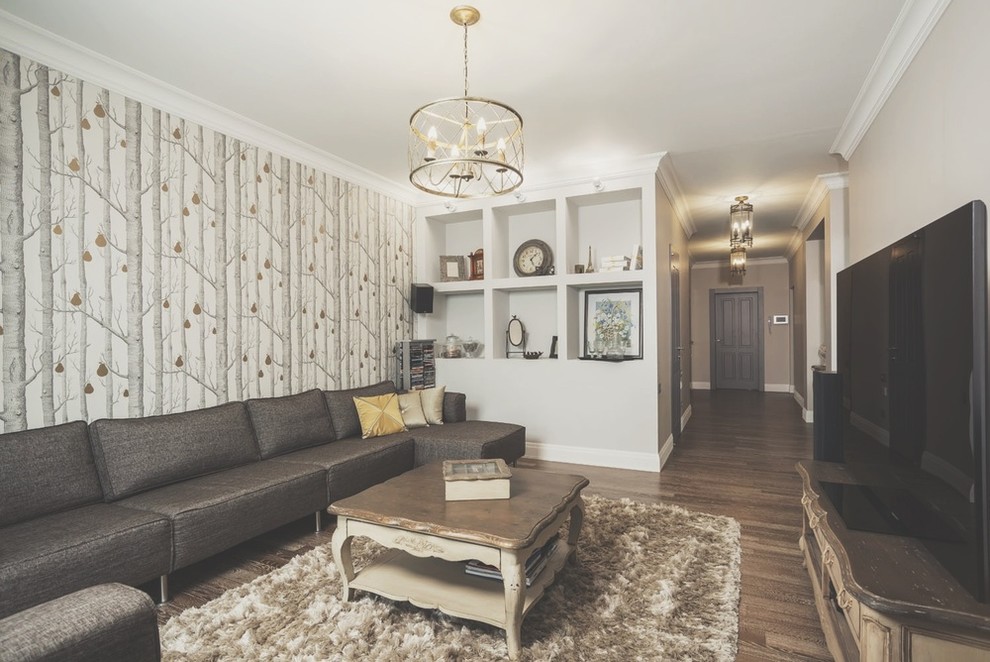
118;460;328;570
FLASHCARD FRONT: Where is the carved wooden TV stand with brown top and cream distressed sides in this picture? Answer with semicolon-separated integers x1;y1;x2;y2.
797;461;990;662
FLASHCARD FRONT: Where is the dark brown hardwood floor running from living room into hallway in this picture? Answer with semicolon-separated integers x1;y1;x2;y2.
155;391;832;661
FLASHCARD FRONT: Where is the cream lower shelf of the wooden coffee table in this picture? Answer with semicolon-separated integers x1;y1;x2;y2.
350;540;574;629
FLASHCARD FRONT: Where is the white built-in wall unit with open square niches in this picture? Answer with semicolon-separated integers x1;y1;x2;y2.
414;167;667;468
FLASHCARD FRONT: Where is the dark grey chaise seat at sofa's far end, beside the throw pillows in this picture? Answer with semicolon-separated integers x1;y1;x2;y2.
414;421;526;467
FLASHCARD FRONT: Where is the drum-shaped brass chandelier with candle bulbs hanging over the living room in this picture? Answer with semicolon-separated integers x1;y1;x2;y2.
409;5;523;198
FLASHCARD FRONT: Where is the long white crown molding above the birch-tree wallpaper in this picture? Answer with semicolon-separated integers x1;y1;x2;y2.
0;10;416;204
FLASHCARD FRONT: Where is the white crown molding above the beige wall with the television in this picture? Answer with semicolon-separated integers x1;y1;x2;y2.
830;0;952;161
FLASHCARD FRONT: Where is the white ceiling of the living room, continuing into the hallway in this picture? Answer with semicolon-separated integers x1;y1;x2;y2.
0;0;906;261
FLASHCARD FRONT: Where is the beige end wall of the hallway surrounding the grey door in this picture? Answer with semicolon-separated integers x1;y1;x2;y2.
691;260;792;390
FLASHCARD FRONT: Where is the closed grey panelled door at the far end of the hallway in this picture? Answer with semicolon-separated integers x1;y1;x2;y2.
712;291;763;391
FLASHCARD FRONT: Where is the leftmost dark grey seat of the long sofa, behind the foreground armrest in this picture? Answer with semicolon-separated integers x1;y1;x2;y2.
0;503;172;617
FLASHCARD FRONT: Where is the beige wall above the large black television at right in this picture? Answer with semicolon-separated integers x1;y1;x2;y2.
849;0;990;262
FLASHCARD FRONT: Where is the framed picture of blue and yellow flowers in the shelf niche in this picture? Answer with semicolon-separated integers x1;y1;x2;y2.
583;288;643;361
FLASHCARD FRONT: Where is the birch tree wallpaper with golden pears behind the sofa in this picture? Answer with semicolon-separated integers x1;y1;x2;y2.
0;50;413;432
